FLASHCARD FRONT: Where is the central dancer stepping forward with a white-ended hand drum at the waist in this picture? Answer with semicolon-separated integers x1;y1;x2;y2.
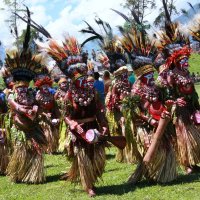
39;37;109;196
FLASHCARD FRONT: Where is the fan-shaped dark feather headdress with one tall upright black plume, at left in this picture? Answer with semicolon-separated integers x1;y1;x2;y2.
5;8;46;82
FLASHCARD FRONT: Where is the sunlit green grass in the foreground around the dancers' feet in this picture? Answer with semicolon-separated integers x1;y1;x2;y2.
0;148;200;200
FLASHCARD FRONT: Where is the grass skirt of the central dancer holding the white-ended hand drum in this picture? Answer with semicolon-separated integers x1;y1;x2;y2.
68;141;106;190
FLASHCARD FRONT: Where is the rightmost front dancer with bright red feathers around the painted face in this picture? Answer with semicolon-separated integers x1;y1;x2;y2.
155;23;200;173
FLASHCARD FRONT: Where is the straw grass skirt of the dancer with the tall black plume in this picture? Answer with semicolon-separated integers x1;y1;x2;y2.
7;142;45;183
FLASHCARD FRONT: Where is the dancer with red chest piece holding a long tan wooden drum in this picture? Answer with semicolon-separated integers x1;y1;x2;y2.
122;28;181;183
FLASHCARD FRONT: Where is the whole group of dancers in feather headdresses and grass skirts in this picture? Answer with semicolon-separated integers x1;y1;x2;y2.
0;7;200;196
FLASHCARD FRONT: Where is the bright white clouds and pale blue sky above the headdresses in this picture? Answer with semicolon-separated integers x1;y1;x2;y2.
0;0;199;49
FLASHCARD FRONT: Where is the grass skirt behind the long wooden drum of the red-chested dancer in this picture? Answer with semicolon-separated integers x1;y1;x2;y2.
135;126;177;183
